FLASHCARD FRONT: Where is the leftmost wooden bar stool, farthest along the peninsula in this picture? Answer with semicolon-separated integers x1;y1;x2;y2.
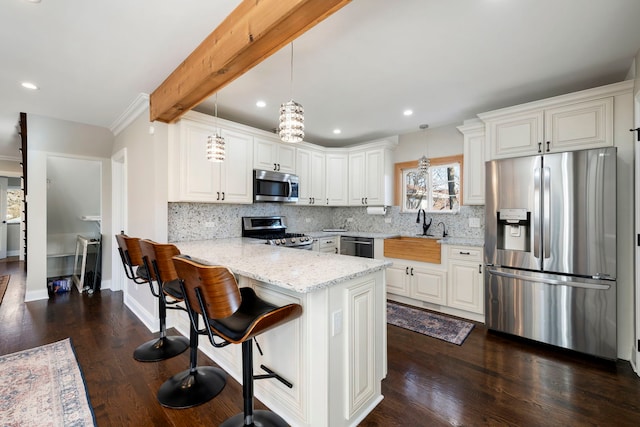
116;234;189;362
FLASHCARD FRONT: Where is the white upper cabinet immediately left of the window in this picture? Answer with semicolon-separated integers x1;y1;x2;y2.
349;147;393;206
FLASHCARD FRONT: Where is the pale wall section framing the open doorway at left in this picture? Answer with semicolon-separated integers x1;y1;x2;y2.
25;115;113;301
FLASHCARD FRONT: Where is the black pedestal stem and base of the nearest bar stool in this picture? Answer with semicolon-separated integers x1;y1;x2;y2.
220;338;289;427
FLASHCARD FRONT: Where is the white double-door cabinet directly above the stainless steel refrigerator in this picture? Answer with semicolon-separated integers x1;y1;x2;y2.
478;82;630;160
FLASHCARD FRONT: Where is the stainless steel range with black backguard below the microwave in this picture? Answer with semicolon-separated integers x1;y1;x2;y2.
242;216;313;249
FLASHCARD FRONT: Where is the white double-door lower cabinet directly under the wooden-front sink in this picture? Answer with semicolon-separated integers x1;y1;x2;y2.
387;260;447;305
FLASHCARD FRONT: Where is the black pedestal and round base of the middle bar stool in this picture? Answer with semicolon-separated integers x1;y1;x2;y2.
157;318;227;409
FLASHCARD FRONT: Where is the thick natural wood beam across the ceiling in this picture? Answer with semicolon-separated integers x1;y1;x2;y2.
149;0;351;123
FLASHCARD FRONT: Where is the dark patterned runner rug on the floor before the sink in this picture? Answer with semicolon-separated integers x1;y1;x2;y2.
387;301;473;345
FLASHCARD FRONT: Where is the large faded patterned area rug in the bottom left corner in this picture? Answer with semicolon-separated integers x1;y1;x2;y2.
0;338;96;427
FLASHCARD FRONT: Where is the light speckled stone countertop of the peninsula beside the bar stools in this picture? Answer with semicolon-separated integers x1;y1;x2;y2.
174;237;392;293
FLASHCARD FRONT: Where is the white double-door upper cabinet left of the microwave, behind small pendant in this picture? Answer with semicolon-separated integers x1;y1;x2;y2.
169;115;253;203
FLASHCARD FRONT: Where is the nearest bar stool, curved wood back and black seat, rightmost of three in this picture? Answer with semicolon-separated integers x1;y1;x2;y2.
173;256;302;427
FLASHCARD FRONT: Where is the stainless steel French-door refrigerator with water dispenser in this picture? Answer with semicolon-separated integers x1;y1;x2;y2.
485;147;617;359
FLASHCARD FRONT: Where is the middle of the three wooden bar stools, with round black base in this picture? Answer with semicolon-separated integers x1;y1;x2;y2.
140;240;227;409
